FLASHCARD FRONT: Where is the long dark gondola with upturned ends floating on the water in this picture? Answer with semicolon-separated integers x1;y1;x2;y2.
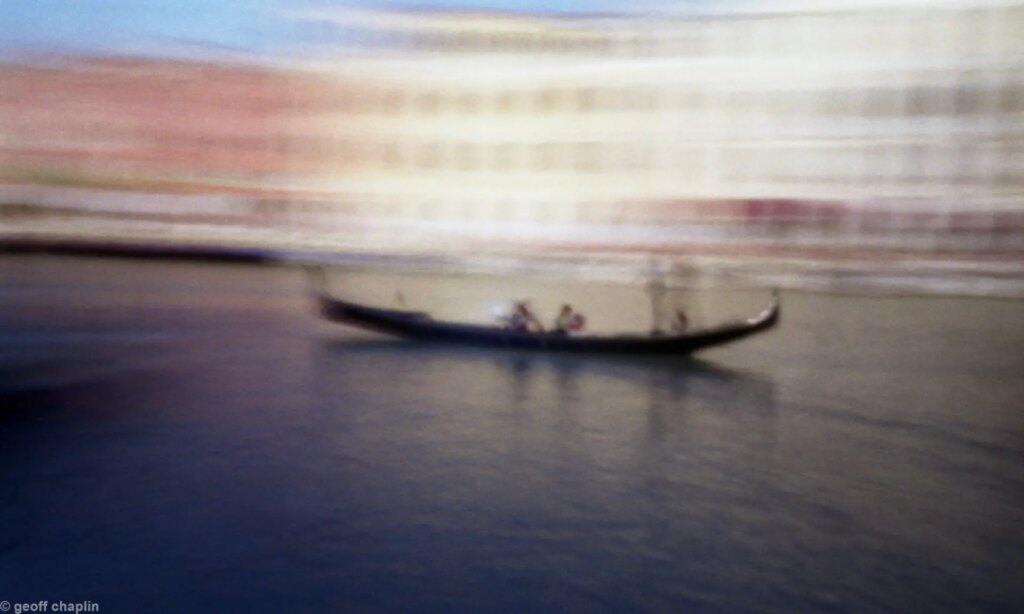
317;284;780;355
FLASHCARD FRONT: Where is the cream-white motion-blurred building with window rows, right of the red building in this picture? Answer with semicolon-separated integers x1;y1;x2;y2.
286;4;1024;256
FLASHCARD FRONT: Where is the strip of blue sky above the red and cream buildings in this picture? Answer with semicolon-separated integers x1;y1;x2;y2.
0;0;983;55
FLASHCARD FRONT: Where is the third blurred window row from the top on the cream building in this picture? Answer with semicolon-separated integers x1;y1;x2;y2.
296;138;1024;185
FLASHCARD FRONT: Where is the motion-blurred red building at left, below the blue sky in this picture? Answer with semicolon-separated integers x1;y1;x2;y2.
0;56;301;180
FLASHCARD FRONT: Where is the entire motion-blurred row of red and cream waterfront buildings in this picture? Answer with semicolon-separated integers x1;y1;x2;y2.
0;2;1024;278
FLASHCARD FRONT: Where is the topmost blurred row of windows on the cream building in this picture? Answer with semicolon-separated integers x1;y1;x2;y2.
295;9;1024;56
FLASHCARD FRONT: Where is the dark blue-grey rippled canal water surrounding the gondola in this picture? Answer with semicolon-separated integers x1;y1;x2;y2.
0;256;1024;612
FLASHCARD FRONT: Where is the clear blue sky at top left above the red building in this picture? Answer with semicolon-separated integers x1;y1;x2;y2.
0;0;685;53
